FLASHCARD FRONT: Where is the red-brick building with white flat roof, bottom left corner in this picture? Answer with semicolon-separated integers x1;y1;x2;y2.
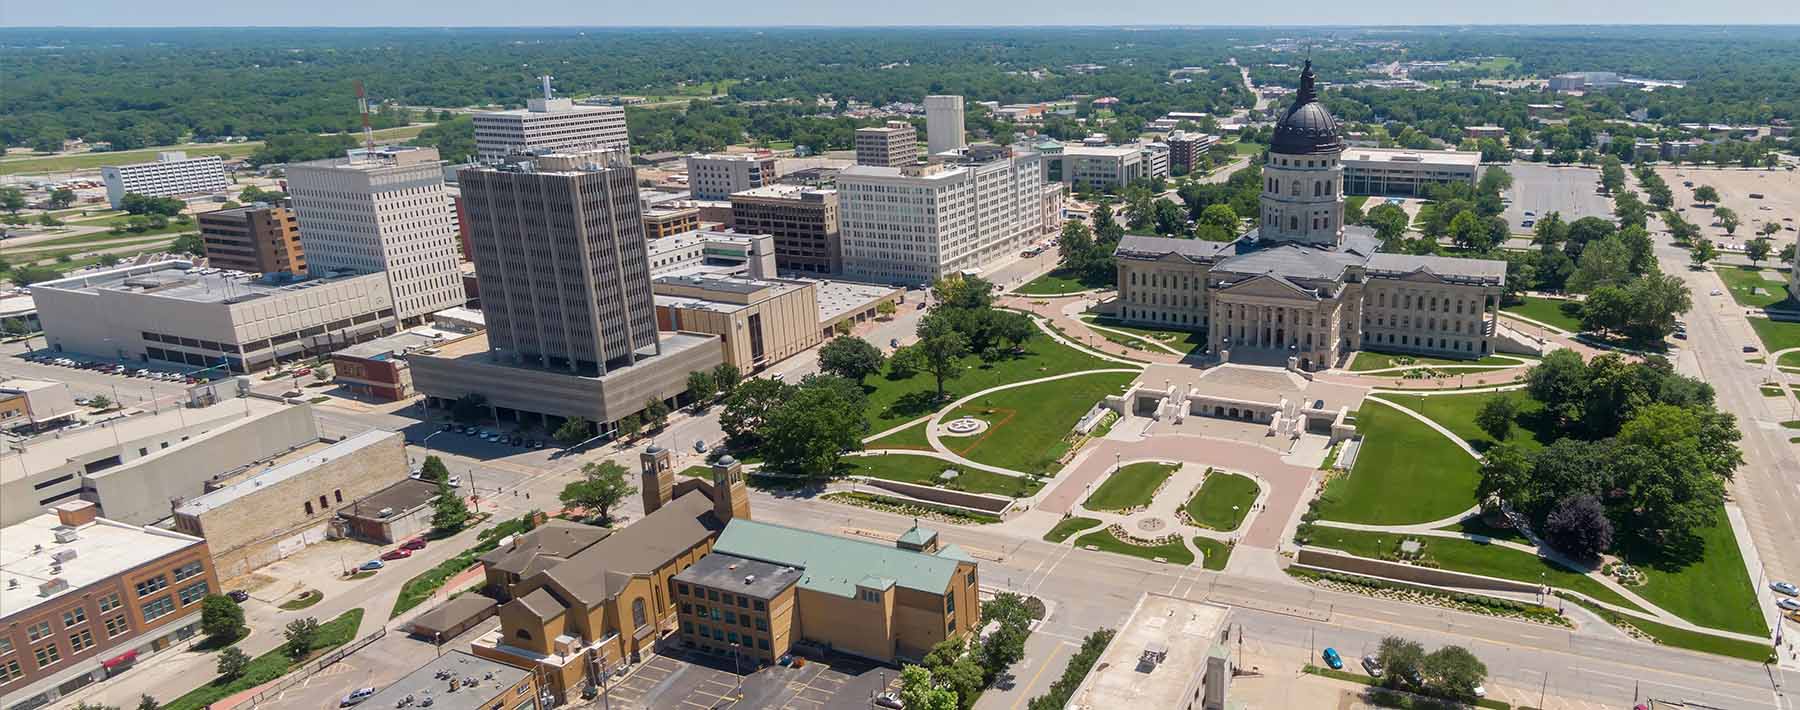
0;501;220;708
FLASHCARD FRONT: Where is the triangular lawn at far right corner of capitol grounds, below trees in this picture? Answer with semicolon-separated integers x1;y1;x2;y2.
1624;508;1769;634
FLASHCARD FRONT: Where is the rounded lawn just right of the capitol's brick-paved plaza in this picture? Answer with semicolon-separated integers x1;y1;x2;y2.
1318;404;1480;524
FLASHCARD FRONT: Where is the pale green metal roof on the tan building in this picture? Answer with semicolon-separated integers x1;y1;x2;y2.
713;519;958;596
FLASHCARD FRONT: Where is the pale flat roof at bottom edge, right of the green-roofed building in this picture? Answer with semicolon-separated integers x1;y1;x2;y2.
1069;593;1231;710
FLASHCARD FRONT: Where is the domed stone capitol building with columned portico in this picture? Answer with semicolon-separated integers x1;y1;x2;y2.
1112;61;1507;371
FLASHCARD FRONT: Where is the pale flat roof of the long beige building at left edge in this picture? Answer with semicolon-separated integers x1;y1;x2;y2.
0;396;288;483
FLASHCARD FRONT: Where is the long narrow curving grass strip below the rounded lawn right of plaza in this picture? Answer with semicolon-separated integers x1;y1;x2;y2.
1312;526;1643;611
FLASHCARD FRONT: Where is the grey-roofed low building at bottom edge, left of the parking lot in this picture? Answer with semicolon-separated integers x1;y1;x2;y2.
364;651;542;710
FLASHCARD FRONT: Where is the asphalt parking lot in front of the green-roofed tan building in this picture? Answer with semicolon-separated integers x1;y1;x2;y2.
601;652;900;710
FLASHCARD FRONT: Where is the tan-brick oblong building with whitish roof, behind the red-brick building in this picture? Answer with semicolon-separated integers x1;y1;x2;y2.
175;429;407;578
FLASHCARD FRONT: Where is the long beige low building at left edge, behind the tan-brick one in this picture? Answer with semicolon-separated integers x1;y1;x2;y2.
0;398;319;524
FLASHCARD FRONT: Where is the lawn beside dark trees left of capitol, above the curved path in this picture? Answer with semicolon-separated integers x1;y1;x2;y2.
864;333;1120;431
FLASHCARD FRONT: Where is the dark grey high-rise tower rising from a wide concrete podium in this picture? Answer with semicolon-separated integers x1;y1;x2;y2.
457;151;661;377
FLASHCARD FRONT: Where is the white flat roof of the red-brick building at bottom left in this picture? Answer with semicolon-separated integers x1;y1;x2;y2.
0;501;203;616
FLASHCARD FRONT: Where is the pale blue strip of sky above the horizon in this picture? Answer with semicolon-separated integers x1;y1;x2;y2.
10;0;1800;27
